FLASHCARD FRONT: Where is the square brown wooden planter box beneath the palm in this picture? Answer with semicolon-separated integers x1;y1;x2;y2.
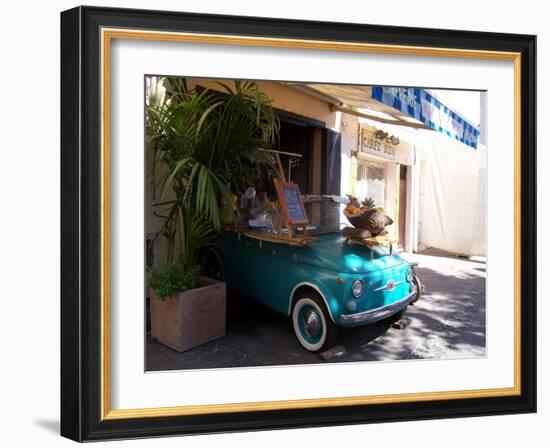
151;277;226;352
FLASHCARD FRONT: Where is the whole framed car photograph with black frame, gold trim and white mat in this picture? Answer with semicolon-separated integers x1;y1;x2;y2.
61;7;536;441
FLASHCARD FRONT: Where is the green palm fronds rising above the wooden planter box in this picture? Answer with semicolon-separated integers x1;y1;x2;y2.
146;78;279;268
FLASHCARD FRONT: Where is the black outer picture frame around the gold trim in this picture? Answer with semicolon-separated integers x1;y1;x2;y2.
61;7;537;441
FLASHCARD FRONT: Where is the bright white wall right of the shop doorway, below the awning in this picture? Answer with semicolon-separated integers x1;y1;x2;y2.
417;136;488;256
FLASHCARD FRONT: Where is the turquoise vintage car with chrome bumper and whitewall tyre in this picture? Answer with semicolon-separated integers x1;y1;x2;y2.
205;195;420;352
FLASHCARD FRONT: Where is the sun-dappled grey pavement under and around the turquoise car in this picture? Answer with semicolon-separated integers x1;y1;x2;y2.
146;251;486;370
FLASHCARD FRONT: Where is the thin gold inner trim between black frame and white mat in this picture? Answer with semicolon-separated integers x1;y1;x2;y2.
100;28;521;420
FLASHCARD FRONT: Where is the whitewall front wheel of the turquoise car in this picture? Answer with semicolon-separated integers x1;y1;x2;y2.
292;291;338;352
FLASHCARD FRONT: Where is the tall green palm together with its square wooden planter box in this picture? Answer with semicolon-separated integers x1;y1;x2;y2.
147;78;279;351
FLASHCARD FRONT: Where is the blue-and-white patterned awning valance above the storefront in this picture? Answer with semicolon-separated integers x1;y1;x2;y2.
372;86;479;149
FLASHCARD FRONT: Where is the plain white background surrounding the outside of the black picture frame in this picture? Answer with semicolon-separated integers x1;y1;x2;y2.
0;0;550;448
